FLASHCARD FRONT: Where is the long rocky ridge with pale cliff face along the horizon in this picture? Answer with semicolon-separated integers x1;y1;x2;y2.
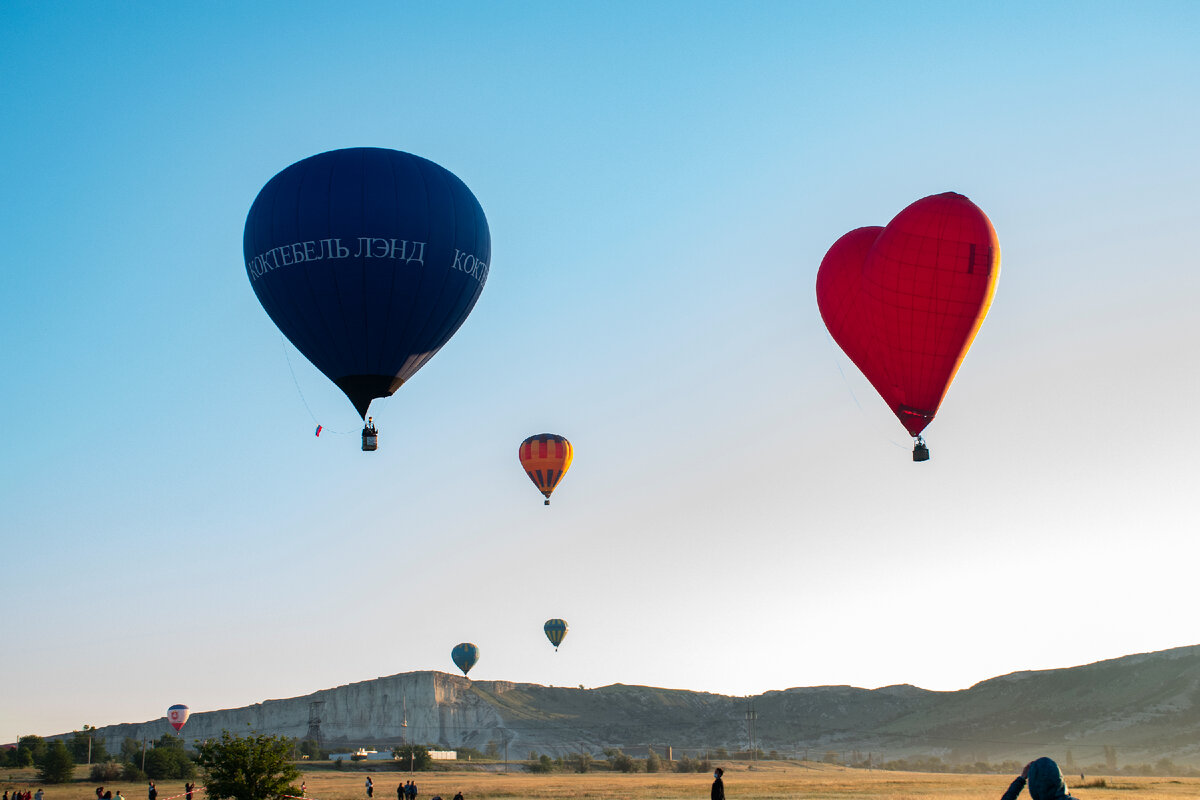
65;646;1200;765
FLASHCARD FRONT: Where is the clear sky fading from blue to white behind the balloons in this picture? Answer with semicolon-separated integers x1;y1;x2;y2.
0;1;1200;741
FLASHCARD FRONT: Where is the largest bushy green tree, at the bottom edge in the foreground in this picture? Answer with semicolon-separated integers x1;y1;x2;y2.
197;730;300;800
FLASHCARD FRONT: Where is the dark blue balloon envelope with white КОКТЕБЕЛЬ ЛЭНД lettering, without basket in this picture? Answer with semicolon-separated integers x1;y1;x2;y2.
242;148;492;419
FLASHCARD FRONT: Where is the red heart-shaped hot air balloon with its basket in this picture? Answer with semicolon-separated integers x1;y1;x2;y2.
817;192;1000;461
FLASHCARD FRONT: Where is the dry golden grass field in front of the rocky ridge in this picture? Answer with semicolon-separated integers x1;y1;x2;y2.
0;763;1200;800
